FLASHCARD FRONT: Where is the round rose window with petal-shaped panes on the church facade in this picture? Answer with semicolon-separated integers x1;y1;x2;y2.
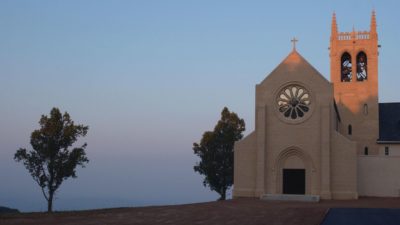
277;85;310;120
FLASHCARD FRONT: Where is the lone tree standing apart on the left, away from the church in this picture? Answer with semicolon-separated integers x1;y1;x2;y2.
14;108;89;212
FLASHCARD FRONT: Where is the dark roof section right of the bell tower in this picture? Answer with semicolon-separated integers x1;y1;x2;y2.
378;102;400;143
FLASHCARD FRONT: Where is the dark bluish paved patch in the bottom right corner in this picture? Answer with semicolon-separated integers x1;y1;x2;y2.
321;208;400;225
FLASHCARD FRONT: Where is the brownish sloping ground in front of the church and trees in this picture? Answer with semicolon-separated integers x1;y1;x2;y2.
0;198;400;225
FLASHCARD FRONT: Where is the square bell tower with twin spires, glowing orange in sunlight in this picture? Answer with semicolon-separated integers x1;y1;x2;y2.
329;11;379;154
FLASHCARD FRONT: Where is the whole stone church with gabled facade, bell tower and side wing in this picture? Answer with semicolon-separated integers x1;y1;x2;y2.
233;11;400;201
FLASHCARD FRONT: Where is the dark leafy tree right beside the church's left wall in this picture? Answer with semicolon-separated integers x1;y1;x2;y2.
193;107;245;200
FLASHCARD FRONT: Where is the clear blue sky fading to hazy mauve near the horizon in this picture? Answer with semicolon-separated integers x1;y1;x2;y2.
0;0;400;211
